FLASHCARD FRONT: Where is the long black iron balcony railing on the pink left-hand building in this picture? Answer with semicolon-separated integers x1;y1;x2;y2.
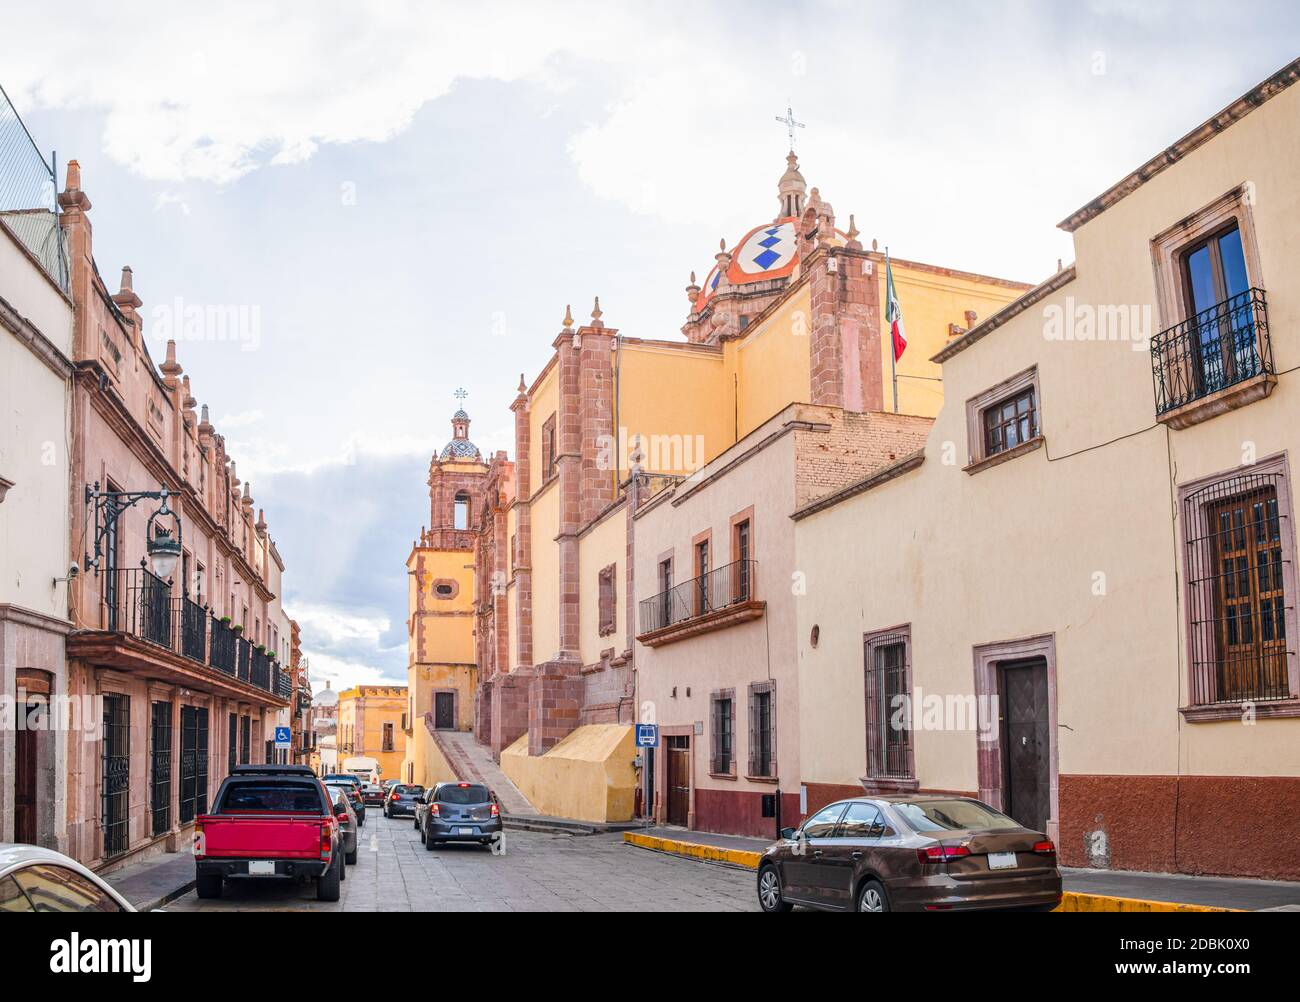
101;567;293;699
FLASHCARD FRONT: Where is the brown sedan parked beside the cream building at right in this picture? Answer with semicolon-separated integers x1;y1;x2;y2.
758;795;1061;911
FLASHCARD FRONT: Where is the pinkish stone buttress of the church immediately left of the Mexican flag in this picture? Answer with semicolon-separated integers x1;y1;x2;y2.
803;247;885;411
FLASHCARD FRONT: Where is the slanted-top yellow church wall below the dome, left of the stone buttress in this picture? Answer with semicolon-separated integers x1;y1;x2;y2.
719;283;813;436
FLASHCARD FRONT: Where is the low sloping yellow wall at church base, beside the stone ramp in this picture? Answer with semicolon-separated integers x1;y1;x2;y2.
501;724;637;821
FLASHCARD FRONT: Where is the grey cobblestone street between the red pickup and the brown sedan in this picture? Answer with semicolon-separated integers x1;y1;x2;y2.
166;810;758;911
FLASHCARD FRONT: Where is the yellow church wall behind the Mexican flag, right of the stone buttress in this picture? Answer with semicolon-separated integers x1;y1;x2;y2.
878;261;1028;417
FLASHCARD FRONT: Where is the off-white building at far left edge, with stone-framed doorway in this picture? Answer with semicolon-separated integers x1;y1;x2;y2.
0;148;75;851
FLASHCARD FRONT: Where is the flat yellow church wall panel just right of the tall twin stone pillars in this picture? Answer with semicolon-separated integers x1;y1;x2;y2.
611;342;735;473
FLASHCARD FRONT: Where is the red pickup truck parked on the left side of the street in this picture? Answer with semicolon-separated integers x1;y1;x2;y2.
194;765;347;901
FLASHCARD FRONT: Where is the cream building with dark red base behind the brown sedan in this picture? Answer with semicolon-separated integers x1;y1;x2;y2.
794;61;1300;880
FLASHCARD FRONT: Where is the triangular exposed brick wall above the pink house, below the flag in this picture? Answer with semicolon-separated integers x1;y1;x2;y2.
794;408;933;508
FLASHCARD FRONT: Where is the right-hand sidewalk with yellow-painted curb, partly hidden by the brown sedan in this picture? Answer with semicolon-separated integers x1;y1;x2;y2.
623;828;1300;911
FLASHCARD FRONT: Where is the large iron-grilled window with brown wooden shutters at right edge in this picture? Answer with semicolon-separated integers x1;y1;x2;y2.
1182;464;1297;706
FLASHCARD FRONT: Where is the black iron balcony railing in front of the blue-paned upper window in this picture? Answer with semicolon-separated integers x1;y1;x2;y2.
1151;289;1274;416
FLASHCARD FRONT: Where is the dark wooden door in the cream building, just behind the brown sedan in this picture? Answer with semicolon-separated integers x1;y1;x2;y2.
1002;658;1052;832
